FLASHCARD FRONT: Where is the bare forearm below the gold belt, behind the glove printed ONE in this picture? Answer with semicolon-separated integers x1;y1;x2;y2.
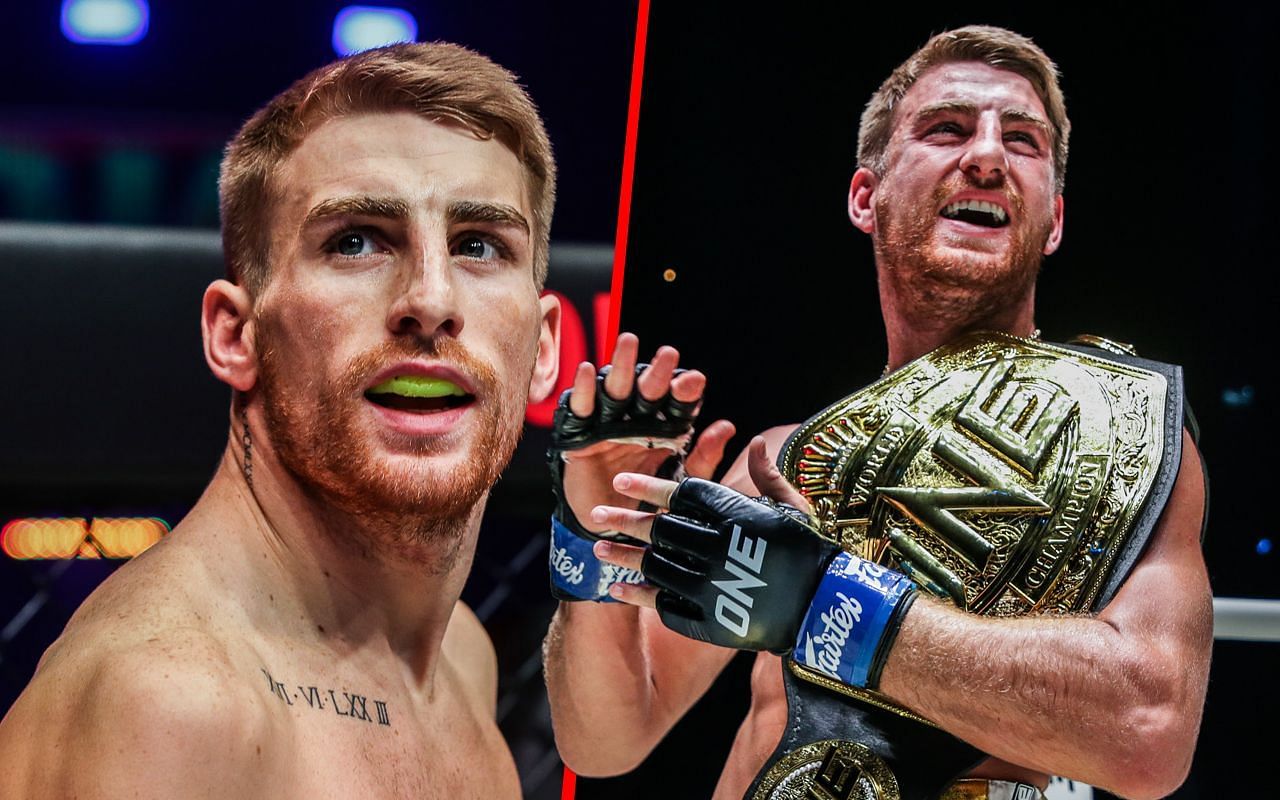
881;595;1212;796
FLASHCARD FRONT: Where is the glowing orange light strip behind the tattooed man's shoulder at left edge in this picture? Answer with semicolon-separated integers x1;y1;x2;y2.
0;517;169;561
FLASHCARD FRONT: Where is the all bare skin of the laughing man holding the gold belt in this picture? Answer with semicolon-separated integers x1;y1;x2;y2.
545;61;1212;800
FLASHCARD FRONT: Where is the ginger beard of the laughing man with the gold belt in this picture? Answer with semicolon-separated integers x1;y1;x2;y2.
873;172;1053;329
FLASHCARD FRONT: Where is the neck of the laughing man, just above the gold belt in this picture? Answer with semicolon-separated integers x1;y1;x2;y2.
879;270;1037;371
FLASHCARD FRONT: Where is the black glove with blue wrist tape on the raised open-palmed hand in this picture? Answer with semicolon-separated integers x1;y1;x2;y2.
547;364;698;603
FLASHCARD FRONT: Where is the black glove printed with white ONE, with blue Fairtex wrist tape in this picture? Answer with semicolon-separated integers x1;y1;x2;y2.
650;479;915;687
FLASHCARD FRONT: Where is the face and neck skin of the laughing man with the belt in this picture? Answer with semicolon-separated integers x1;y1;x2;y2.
849;61;1064;366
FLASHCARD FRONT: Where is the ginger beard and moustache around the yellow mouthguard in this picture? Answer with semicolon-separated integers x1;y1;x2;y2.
259;335;532;570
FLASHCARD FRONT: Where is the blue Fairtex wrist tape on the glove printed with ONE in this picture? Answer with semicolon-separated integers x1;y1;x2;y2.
792;553;915;687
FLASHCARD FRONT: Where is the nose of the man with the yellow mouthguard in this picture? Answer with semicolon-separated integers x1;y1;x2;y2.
387;244;462;337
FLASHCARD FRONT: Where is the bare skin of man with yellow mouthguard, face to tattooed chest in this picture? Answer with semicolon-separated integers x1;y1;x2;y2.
0;113;559;800
